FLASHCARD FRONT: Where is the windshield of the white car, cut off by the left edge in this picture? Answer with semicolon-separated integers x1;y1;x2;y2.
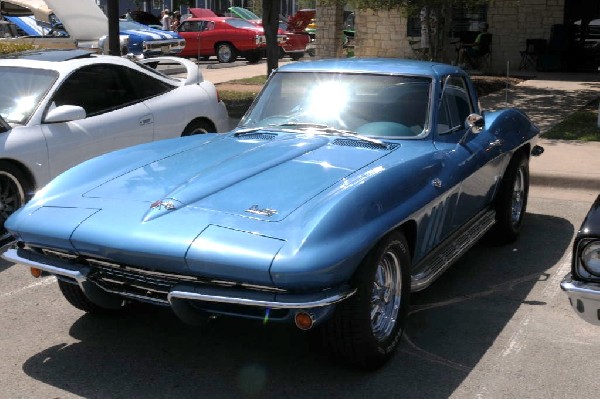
0;67;58;124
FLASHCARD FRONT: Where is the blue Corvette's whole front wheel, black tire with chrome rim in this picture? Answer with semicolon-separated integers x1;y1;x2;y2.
315;233;410;370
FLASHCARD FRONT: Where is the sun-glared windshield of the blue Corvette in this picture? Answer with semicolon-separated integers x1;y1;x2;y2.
239;72;431;137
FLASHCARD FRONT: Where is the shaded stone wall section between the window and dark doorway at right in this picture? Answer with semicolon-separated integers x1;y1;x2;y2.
487;0;565;72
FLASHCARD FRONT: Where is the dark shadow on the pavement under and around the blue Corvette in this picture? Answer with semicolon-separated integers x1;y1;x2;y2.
23;214;574;398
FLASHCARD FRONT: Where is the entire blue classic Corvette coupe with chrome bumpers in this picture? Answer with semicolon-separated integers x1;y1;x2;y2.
3;59;542;369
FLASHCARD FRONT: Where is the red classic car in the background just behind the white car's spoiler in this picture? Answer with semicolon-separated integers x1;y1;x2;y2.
177;17;285;63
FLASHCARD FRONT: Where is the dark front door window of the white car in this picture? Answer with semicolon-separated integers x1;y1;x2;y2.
51;64;137;116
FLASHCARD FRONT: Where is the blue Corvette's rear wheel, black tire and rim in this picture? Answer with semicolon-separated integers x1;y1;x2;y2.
491;153;529;244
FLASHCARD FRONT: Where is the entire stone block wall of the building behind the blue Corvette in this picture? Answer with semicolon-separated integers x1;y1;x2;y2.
316;0;565;73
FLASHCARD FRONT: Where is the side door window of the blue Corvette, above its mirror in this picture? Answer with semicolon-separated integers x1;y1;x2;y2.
438;76;473;134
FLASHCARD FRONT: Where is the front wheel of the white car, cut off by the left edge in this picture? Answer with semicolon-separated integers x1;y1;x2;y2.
0;161;33;240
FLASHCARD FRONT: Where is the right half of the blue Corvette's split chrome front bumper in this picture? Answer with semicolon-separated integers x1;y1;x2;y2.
168;289;356;309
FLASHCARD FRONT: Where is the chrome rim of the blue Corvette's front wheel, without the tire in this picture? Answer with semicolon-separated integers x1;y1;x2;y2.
371;248;402;342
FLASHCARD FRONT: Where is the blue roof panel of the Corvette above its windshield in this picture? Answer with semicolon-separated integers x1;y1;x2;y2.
277;58;464;78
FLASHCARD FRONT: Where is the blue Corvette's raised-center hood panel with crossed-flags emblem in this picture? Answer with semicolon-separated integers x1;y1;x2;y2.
84;132;392;222
